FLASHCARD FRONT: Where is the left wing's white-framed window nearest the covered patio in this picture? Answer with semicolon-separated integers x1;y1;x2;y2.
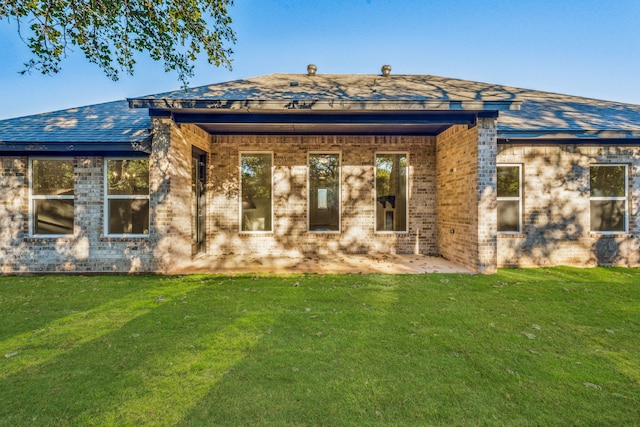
105;159;149;235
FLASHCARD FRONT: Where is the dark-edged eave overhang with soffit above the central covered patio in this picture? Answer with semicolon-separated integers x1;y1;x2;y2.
129;98;520;135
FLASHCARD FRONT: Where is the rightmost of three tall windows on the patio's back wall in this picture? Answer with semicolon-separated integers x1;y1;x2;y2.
375;153;408;233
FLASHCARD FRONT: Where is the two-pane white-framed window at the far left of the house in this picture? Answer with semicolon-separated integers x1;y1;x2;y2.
30;159;74;235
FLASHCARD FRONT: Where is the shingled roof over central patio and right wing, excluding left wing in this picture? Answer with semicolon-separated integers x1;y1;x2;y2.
129;74;640;139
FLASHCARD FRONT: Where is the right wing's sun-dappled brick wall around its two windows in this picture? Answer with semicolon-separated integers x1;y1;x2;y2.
497;144;640;266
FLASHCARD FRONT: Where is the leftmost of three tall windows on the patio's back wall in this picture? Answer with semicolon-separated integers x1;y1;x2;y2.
240;153;273;232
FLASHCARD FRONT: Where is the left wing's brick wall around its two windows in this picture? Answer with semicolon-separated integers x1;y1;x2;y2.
0;156;156;273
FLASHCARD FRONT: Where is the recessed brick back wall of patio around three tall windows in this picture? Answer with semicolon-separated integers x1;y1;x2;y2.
202;135;437;255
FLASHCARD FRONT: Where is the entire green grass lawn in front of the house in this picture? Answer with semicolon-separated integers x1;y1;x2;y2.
0;268;640;426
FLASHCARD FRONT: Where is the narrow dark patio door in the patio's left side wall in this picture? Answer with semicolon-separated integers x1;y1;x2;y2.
191;147;207;255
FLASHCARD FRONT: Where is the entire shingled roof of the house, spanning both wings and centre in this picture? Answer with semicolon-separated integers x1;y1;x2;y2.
0;74;640;147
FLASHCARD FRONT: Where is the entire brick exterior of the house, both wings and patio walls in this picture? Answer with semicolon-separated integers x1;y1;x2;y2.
8;119;640;273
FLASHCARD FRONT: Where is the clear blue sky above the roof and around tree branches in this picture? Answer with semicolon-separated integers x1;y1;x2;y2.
0;0;640;119
